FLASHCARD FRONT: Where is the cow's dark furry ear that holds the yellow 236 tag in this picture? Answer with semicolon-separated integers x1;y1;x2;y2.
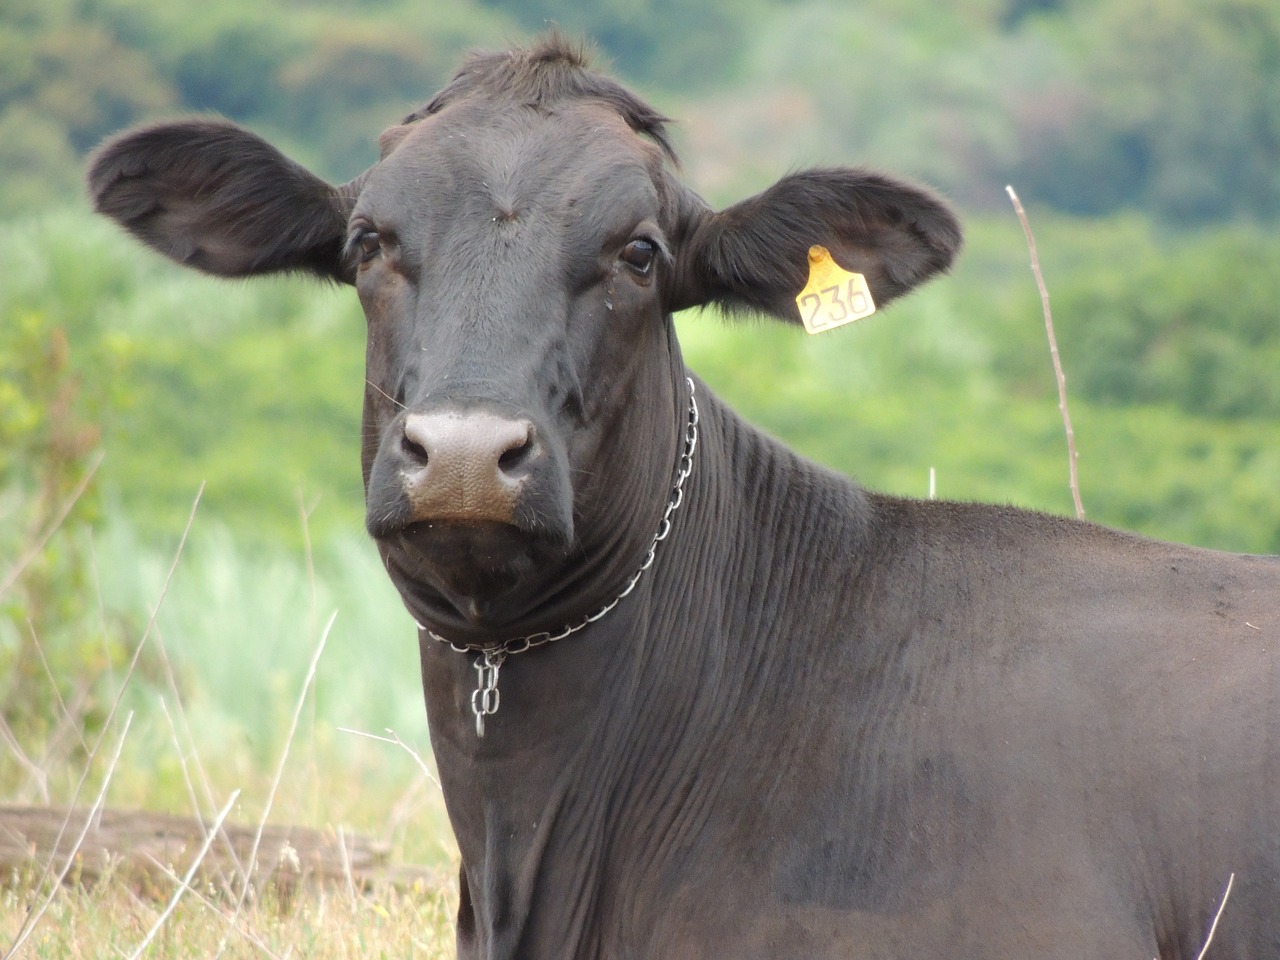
669;169;961;323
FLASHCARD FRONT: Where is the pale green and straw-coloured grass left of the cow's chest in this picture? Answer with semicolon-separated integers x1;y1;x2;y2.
0;499;457;960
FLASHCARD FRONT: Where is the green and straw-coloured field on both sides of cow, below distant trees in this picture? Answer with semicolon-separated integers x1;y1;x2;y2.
0;203;1280;957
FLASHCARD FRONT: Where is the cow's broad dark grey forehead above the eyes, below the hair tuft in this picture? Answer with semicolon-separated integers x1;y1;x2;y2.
351;102;676;308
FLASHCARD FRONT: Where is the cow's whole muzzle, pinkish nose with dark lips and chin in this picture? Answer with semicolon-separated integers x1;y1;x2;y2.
365;402;573;632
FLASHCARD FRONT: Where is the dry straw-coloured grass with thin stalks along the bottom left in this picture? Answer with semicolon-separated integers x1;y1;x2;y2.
0;495;457;960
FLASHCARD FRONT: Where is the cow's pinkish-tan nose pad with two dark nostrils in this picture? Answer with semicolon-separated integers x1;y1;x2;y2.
402;410;540;524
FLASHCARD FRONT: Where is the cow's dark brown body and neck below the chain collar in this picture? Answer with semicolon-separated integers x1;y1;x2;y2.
422;390;1280;959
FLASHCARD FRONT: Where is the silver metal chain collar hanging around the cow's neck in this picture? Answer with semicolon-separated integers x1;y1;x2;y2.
417;378;698;737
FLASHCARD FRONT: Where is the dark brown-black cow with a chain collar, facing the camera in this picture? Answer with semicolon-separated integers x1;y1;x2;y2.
88;36;1280;960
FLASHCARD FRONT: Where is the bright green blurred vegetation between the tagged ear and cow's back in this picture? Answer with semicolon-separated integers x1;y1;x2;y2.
682;214;1280;553
